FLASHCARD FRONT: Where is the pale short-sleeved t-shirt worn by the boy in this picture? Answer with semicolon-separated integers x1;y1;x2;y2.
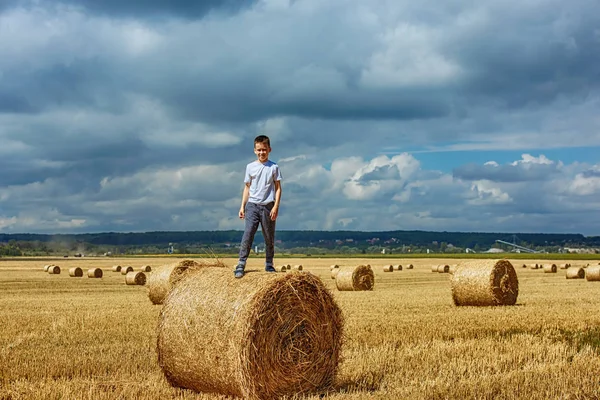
244;160;281;204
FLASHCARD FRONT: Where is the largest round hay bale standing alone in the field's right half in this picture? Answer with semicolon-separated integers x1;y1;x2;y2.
450;260;519;306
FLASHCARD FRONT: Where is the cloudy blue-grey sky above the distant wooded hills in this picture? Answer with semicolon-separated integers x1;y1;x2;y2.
0;0;600;236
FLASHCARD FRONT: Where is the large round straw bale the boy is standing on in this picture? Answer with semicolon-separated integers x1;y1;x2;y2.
157;268;343;400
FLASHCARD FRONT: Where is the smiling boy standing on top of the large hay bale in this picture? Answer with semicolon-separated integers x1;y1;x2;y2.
234;135;281;278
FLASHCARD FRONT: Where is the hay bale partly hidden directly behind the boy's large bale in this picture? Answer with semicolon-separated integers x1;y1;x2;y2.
147;260;225;304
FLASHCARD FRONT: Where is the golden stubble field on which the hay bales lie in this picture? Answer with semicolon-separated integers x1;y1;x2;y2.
0;258;600;399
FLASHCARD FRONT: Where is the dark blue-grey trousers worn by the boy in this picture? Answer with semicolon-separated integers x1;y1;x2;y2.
238;202;275;267
